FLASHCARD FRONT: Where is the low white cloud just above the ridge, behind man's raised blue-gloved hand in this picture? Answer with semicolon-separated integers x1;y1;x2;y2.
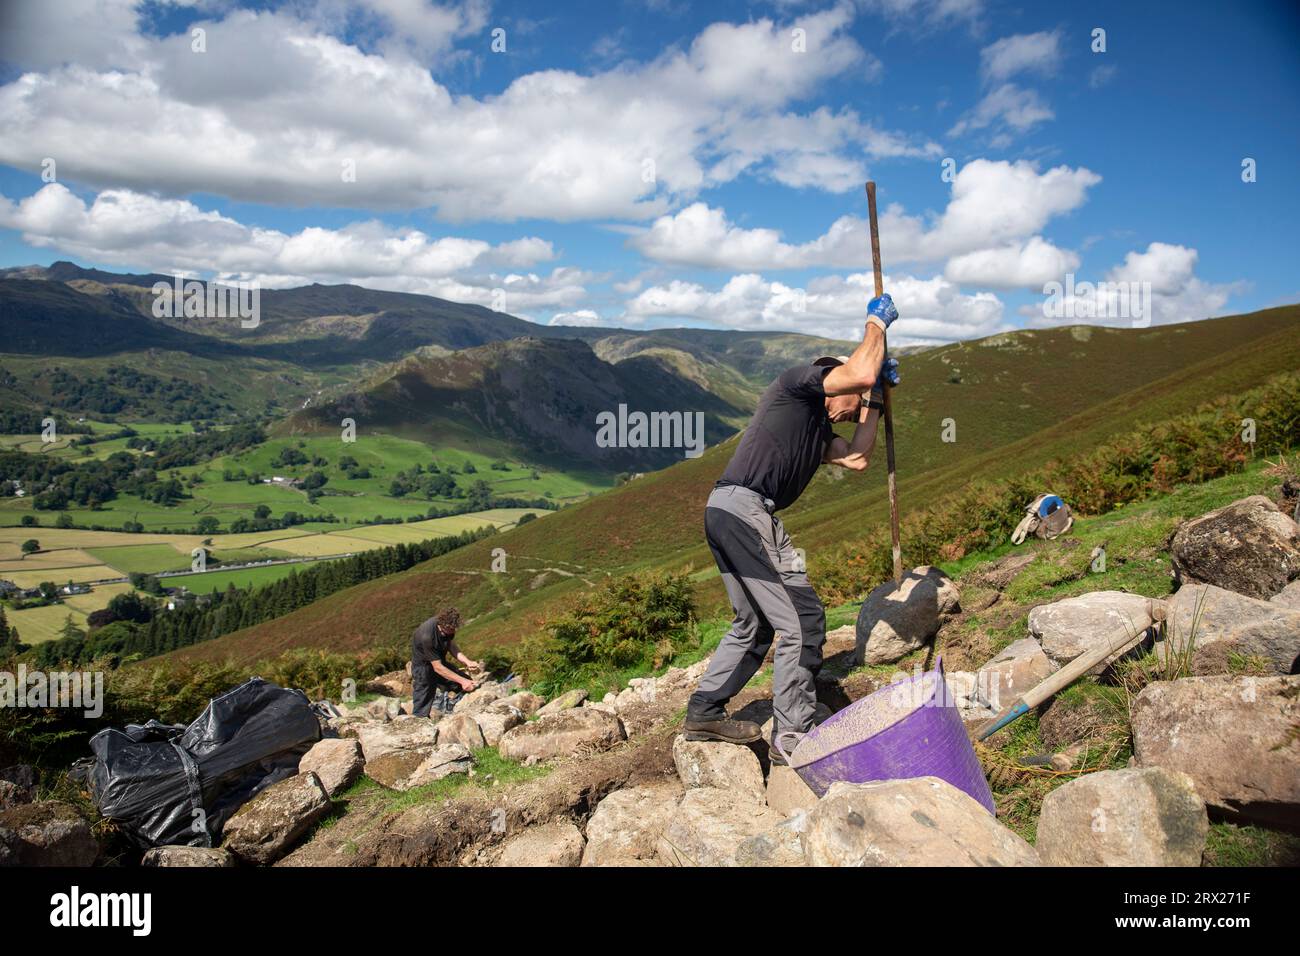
623;273;1008;345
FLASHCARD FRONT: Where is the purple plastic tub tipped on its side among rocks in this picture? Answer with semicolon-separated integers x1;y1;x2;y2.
789;661;996;814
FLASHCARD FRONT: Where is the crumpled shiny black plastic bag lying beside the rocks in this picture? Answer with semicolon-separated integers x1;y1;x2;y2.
90;678;321;847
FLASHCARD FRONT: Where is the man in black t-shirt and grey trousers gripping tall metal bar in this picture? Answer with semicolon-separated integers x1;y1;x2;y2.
684;295;898;763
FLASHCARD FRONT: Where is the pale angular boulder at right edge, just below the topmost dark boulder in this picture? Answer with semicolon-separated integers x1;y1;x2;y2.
1157;584;1300;674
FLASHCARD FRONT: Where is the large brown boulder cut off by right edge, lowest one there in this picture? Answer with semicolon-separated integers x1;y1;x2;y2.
1131;676;1300;827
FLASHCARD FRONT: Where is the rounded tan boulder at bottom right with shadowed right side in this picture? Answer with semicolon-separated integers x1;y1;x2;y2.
1035;767;1209;866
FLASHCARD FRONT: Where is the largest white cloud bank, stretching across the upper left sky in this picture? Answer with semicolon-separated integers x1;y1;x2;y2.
0;0;937;221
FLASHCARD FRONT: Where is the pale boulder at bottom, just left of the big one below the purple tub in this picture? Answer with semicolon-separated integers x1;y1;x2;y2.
655;787;783;866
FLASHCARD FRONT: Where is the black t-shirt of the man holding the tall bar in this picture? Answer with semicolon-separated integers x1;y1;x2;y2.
718;365;835;510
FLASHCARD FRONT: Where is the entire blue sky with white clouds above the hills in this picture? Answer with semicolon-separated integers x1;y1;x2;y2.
0;0;1300;342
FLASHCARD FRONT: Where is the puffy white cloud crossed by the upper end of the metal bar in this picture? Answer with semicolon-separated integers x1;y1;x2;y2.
628;160;1101;287
